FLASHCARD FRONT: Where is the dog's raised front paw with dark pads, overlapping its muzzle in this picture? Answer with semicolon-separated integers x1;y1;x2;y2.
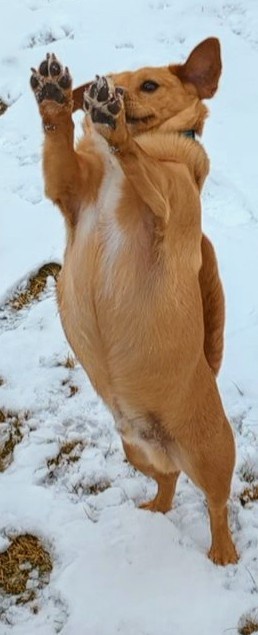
83;75;123;130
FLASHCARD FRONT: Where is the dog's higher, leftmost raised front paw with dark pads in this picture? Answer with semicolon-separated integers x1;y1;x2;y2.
30;53;72;104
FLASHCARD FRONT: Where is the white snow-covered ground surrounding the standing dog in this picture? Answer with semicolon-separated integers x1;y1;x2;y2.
0;0;258;635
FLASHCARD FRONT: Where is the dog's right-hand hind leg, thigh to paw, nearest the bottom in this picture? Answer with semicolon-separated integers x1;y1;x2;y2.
176;377;238;565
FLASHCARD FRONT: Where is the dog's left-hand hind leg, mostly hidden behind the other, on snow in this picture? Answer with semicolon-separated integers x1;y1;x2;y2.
123;441;179;514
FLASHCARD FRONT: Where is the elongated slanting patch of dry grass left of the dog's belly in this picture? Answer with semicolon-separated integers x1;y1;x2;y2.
8;262;61;311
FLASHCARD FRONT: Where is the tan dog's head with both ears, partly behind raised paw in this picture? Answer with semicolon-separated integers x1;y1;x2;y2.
73;37;222;134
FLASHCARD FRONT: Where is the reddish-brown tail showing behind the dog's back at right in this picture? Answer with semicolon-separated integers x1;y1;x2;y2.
199;235;225;375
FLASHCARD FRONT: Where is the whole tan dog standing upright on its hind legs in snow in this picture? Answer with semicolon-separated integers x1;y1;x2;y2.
31;38;238;565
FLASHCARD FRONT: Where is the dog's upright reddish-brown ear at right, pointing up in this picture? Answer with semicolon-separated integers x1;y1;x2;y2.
174;37;222;99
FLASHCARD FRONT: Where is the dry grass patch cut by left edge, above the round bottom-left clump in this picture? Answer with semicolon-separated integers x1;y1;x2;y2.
0;409;29;472
